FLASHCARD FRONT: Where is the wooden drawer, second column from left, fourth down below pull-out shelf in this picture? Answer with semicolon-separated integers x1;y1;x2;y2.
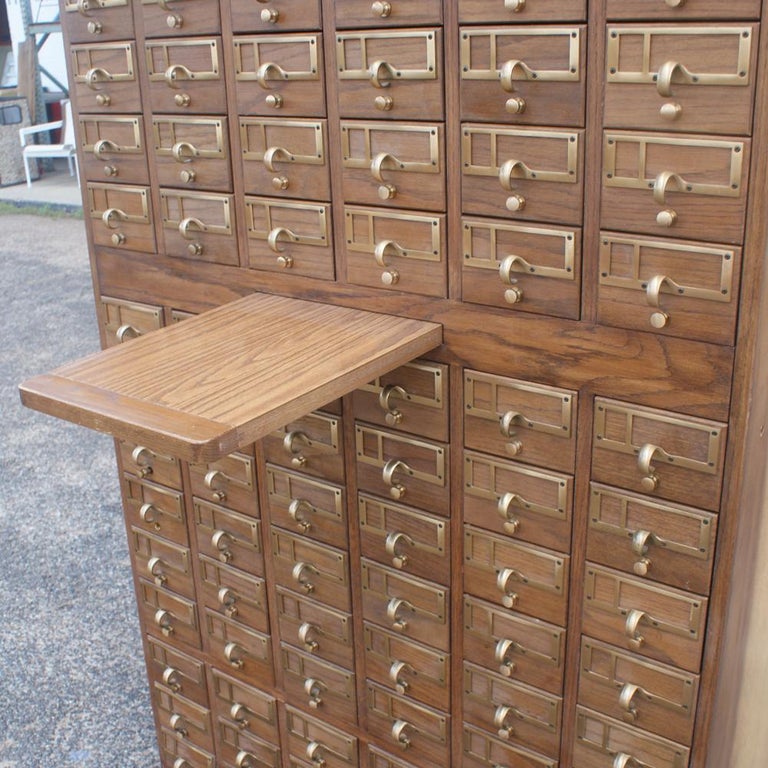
205;608;275;686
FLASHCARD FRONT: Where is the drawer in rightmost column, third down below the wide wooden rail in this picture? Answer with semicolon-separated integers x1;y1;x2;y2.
583;563;708;672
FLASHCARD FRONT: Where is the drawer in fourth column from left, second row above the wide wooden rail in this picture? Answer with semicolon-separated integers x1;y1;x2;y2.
341;121;445;211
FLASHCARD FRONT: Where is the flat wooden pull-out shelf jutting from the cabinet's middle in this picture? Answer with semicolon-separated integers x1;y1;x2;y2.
19;293;443;463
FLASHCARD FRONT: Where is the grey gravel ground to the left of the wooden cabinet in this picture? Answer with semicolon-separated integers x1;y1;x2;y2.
0;213;159;768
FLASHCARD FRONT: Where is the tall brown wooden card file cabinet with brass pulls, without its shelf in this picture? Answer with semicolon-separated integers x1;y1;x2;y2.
19;0;768;768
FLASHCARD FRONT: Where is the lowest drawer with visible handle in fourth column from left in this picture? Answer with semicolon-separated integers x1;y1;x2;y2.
366;682;451;768
